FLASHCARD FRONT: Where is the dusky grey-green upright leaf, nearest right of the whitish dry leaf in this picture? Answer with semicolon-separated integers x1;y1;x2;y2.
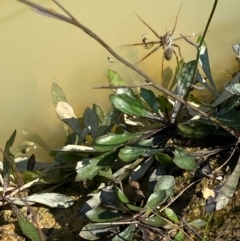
83;108;99;139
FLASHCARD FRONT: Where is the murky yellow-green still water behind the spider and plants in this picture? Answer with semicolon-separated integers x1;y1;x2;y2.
0;0;240;162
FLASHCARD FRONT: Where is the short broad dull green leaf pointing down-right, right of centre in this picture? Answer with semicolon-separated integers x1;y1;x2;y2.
173;146;198;170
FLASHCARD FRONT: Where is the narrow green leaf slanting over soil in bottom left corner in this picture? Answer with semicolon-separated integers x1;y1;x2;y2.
12;206;47;241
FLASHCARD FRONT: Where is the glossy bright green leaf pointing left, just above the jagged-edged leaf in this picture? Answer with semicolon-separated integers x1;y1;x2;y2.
93;132;139;152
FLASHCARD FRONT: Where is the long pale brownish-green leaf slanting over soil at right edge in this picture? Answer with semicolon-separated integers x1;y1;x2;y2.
216;156;240;210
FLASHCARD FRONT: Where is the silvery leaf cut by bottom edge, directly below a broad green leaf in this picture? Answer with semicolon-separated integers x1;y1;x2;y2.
79;223;119;240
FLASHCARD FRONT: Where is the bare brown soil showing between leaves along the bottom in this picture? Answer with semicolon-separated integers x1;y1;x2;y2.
0;153;240;241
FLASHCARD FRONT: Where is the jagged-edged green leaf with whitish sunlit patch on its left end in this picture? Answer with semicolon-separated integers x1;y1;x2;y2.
75;152;117;182
